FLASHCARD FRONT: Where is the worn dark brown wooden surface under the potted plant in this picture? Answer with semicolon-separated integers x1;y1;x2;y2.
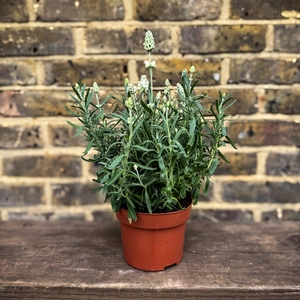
0;221;300;300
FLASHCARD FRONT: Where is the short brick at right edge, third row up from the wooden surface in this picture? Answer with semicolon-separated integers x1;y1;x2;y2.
266;153;300;176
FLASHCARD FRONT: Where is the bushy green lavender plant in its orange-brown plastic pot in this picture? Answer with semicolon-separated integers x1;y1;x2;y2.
69;31;235;271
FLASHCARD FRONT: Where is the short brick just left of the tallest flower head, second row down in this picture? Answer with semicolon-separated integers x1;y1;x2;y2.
84;27;129;54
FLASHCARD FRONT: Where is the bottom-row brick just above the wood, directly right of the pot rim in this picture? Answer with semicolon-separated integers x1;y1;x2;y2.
190;209;253;222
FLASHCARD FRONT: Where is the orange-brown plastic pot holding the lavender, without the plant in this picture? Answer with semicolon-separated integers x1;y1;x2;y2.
116;205;191;271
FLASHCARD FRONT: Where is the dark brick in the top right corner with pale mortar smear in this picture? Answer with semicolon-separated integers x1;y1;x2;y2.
230;0;300;20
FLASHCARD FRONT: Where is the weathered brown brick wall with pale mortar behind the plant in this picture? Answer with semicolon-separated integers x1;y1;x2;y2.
0;0;300;221
